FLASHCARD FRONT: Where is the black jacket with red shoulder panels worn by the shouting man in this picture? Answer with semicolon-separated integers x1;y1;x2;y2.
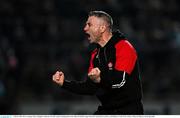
63;32;143;114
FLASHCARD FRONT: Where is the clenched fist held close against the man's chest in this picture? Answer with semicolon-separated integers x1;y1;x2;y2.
88;68;101;83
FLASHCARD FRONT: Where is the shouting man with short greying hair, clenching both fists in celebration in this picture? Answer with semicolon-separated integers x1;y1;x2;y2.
52;11;143;115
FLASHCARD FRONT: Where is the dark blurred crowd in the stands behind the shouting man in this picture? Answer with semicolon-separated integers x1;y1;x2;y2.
0;0;180;114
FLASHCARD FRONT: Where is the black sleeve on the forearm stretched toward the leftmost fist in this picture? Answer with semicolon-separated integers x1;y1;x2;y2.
62;78;98;95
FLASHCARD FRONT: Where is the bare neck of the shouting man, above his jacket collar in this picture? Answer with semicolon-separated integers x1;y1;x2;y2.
98;32;112;47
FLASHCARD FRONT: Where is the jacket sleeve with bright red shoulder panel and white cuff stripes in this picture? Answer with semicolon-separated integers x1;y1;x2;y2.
101;40;137;88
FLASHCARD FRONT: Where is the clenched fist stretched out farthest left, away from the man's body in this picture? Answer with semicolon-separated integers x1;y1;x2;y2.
52;71;64;86
